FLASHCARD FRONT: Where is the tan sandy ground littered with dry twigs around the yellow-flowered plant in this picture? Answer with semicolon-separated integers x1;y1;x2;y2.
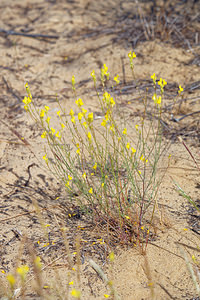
0;0;200;300
